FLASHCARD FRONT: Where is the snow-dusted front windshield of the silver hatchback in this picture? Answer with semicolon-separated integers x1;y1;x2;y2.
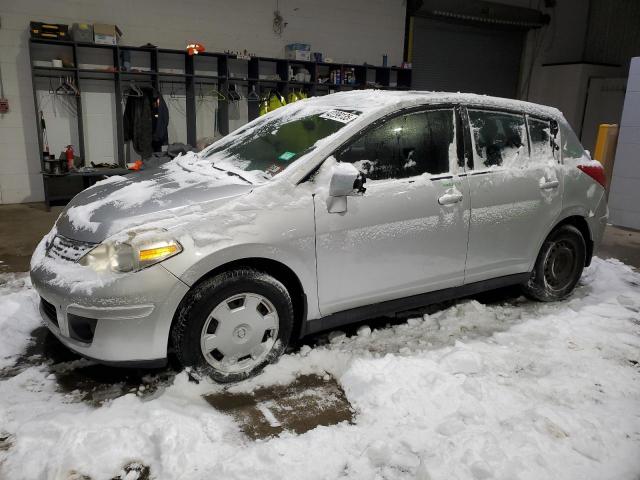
202;110;361;179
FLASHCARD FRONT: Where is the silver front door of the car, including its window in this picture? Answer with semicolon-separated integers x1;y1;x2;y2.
314;108;470;315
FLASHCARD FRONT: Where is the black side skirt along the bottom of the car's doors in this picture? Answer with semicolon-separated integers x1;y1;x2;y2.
300;272;531;338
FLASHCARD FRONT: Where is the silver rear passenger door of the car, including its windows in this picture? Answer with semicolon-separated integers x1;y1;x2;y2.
465;107;563;283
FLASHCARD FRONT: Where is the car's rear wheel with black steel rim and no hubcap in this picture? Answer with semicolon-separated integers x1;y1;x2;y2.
523;225;587;302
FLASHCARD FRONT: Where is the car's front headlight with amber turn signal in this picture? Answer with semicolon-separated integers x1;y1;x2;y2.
78;230;182;272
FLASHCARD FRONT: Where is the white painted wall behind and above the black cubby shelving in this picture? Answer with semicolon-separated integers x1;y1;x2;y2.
0;0;406;203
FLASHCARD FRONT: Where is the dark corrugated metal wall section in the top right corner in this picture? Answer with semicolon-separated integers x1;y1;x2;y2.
584;0;640;68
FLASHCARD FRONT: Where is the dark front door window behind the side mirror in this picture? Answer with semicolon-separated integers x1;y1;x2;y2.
337;109;457;180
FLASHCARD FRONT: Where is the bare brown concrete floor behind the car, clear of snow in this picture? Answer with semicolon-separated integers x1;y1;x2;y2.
0;203;640;273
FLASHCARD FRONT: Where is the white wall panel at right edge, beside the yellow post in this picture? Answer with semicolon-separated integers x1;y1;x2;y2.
609;57;640;229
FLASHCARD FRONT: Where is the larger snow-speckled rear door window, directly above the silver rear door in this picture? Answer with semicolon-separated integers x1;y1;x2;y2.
469;110;529;169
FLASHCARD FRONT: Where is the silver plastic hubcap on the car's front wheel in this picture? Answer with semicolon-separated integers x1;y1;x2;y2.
200;293;279;373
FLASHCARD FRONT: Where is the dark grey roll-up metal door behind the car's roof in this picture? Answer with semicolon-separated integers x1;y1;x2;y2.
412;17;524;98
